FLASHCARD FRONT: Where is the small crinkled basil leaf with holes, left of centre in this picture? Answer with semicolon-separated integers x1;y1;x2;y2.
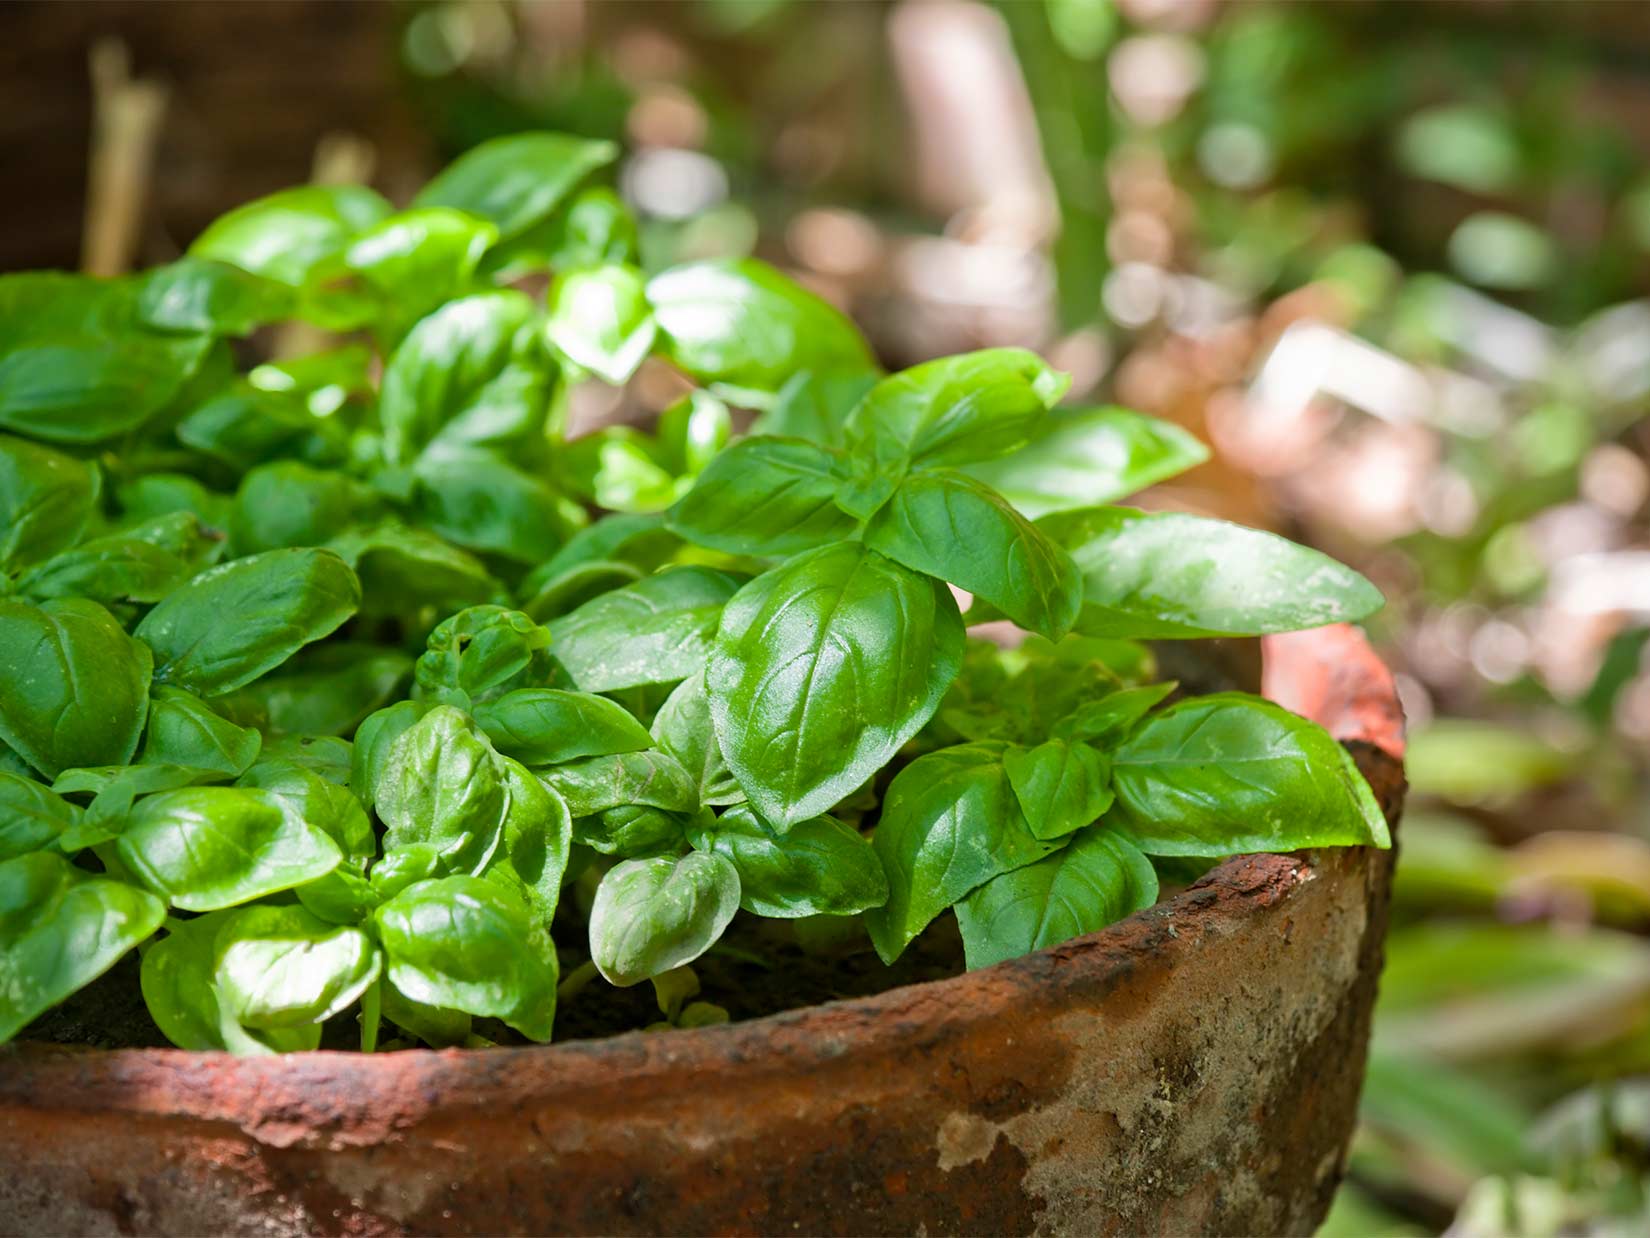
413;606;556;706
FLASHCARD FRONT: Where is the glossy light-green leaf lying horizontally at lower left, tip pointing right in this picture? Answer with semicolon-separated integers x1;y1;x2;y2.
116;787;343;911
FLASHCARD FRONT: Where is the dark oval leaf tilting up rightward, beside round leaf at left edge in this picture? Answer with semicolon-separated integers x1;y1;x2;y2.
138;550;361;693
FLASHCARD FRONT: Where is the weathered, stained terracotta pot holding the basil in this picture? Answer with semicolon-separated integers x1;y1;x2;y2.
0;627;1404;1235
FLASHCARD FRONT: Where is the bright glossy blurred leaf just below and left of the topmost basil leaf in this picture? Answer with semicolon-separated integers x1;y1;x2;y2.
343;206;498;338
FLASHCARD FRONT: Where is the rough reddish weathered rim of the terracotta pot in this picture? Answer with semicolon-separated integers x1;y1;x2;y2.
0;626;1404;1122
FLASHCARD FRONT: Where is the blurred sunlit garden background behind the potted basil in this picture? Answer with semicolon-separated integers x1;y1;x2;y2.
0;0;1650;1236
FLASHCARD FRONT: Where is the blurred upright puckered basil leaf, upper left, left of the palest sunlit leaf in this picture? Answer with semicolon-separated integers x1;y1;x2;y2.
378;289;554;465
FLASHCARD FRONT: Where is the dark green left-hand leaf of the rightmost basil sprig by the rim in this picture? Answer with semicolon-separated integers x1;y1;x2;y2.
865;743;1064;962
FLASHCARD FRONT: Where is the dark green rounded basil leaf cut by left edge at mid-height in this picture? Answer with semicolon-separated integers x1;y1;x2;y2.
0;598;152;777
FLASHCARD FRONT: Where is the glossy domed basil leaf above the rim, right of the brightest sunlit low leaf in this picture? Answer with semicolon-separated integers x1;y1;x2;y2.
373;877;556;1040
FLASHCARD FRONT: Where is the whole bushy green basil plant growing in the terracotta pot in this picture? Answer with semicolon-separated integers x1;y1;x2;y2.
0;134;1388;1053
